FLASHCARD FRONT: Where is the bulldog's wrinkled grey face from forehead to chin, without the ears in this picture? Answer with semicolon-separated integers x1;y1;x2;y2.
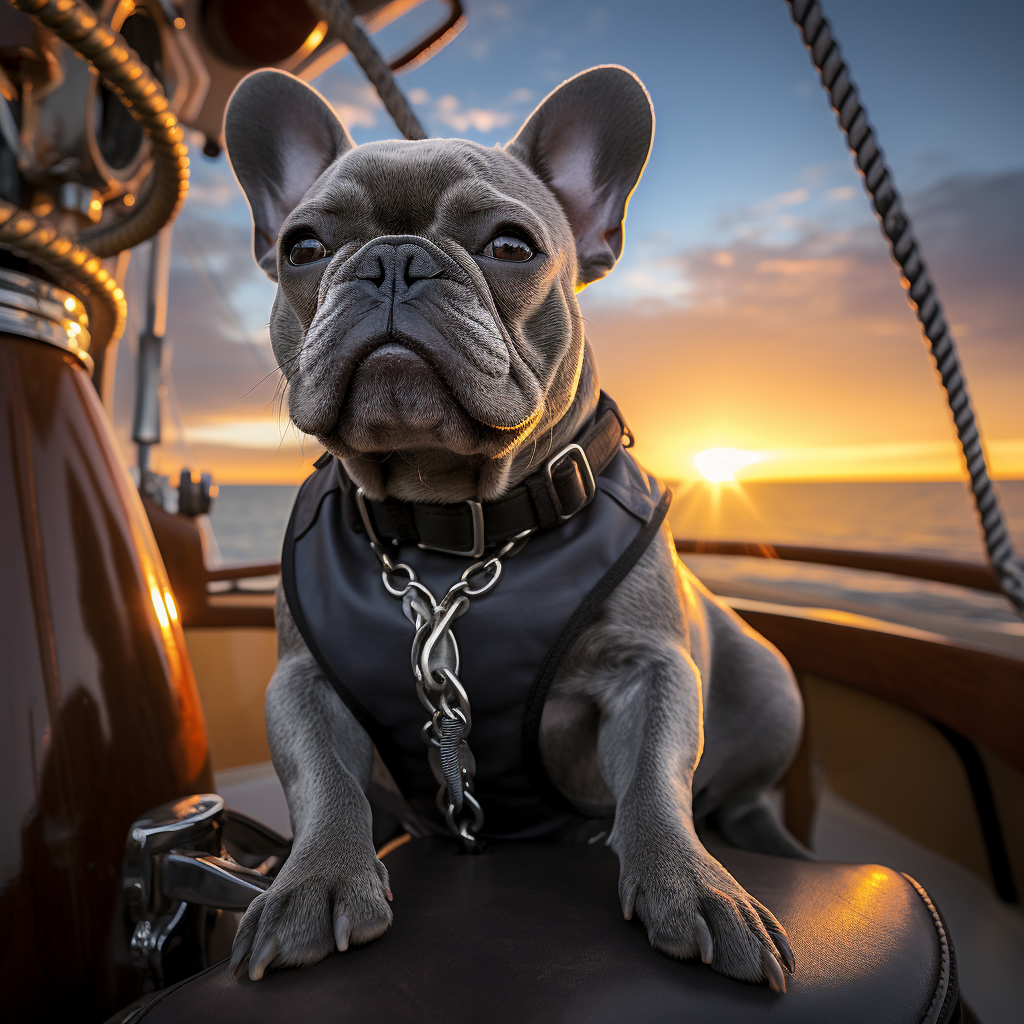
275;140;583;458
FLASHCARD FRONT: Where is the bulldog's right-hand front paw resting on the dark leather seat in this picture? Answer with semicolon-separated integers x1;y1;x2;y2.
618;837;796;992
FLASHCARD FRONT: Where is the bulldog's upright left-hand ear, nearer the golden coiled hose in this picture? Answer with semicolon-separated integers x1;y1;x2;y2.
224;69;355;281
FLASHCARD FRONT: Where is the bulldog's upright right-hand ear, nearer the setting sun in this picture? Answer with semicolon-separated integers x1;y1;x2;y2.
506;65;654;287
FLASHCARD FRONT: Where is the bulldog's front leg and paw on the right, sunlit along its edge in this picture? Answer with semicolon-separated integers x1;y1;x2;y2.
598;637;793;991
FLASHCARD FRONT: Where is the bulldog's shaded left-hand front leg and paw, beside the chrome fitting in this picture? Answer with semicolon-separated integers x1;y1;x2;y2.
231;592;391;981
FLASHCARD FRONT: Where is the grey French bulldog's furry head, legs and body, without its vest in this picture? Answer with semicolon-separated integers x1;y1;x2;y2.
225;67;807;992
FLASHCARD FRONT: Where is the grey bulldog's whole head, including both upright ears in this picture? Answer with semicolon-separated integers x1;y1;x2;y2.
225;68;653;498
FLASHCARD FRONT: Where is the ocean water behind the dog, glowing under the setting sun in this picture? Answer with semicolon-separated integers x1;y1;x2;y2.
210;480;1024;656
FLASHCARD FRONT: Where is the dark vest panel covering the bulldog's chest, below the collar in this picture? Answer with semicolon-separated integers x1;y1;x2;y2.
283;452;656;835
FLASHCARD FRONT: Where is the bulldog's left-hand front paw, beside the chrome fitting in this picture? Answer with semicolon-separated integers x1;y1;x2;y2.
230;851;391;981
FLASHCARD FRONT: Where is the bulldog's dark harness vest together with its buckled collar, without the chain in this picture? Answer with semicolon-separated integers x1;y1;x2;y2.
282;395;671;838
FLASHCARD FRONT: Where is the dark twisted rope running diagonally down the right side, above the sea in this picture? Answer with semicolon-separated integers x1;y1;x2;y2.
786;0;1024;615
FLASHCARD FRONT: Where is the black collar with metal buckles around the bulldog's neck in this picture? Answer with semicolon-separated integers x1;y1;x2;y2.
316;391;633;558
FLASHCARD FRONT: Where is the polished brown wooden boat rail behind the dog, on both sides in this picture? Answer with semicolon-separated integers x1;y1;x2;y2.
145;502;1024;771
